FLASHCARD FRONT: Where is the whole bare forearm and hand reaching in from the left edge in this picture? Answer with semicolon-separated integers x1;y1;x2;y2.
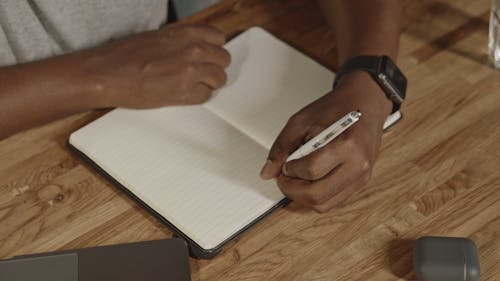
0;25;230;139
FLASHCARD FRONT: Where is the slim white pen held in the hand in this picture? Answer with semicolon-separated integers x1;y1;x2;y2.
286;111;361;162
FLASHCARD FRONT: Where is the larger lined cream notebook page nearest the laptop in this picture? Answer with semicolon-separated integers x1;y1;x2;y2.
70;106;284;249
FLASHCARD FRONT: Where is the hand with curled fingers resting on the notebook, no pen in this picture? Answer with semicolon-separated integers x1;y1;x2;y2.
81;25;230;108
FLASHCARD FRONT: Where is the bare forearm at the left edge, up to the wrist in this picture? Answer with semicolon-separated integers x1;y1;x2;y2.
0;54;99;139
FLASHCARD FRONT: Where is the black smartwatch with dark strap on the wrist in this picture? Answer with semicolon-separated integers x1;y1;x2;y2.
333;56;407;113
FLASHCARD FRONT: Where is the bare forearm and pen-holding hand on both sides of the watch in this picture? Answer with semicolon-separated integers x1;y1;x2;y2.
261;0;400;209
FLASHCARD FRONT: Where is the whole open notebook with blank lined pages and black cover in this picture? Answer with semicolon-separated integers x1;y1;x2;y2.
69;27;400;258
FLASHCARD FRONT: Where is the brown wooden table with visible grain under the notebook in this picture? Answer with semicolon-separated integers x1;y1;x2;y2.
0;0;500;281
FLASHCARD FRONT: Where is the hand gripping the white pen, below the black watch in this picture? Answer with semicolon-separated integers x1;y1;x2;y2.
261;72;392;212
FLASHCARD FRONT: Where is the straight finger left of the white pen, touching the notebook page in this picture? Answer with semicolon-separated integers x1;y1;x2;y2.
260;122;307;180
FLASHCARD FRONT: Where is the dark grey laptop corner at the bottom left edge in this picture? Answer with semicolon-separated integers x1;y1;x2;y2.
0;239;191;281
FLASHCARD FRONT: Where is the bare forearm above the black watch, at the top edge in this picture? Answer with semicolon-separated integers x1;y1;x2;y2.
318;0;402;65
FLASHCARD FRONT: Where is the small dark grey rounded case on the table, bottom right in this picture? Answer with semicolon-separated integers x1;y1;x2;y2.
413;236;480;281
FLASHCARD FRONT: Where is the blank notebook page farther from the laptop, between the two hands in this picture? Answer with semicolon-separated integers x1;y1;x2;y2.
205;27;334;149
